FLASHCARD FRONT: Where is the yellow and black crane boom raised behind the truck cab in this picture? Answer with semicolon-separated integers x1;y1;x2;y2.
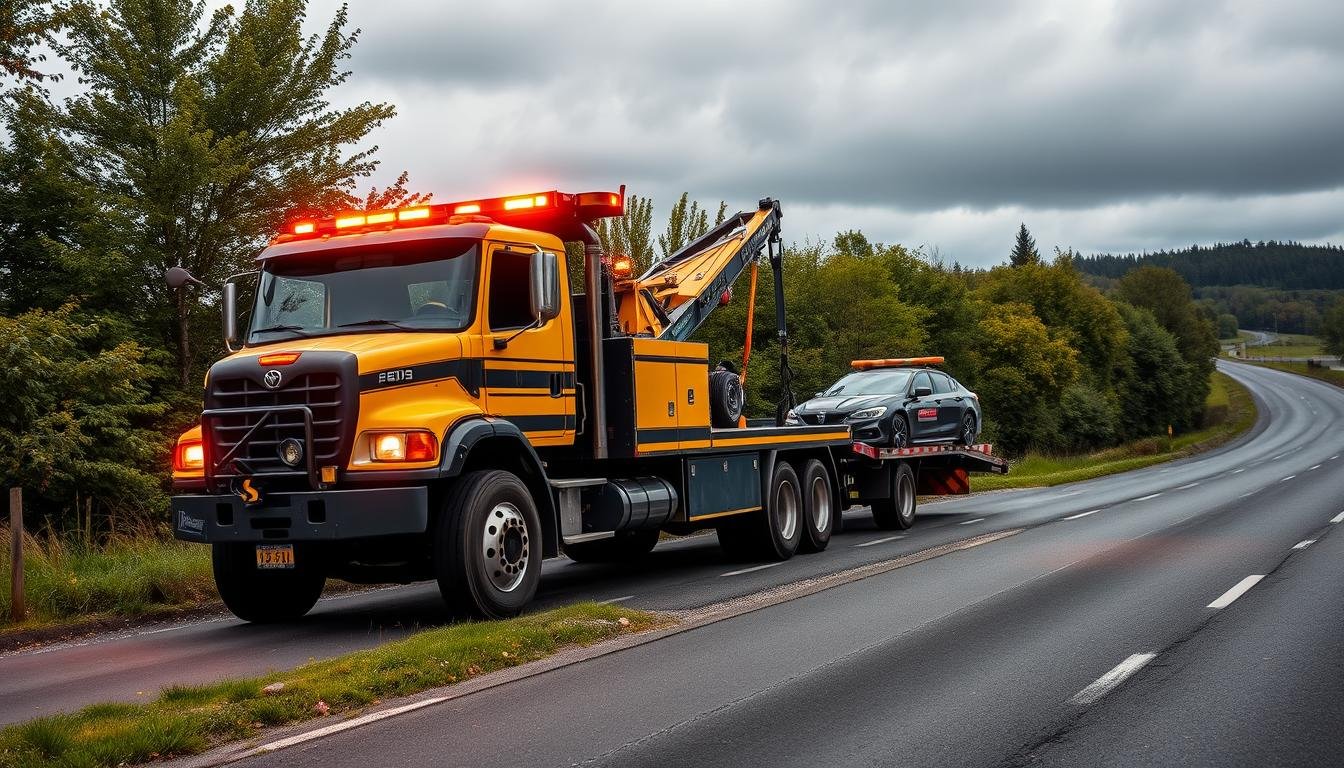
613;198;784;342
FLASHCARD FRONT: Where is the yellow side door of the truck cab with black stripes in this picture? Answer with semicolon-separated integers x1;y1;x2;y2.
481;243;577;445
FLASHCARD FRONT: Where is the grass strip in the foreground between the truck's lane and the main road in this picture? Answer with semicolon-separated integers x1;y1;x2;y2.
0;603;671;768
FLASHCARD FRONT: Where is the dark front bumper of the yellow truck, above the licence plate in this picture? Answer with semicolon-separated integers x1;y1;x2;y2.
172;486;429;543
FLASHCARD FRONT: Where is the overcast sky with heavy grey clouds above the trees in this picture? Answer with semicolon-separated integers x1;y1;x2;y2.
317;0;1344;265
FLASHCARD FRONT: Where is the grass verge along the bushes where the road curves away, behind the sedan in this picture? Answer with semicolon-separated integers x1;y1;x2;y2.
972;371;1255;491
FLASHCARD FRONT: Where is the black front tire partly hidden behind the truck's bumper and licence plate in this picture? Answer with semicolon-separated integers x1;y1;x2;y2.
210;542;327;624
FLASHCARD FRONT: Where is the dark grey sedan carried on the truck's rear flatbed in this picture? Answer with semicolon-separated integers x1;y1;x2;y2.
786;360;984;448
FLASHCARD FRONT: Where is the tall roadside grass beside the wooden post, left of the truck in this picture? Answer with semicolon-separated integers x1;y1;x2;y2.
0;529;218;632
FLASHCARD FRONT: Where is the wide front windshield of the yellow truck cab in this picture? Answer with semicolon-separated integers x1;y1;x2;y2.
247;238;480;344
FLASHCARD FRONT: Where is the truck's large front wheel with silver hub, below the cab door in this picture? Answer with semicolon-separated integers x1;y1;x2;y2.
434;469;542;619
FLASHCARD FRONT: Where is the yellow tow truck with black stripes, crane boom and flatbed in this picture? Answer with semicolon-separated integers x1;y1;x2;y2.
168;187;1007;621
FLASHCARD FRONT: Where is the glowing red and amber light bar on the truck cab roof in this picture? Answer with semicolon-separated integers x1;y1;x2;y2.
276;186;625;242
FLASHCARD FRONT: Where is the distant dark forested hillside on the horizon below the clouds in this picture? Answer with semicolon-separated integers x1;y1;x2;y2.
1077;239;1344;291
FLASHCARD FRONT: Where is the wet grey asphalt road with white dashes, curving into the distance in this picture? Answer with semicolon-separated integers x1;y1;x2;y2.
0;364;1344;768
